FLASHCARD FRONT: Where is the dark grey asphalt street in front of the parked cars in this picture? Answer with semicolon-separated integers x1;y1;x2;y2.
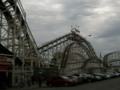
8;77;120;90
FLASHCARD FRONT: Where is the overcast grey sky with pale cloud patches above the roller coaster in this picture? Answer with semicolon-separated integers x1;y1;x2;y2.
21;0;120;55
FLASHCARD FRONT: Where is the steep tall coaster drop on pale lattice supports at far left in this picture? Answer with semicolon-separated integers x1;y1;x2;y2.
0;0;42;66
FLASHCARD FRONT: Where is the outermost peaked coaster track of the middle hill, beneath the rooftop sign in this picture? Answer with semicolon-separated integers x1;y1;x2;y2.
38;33;97;58
